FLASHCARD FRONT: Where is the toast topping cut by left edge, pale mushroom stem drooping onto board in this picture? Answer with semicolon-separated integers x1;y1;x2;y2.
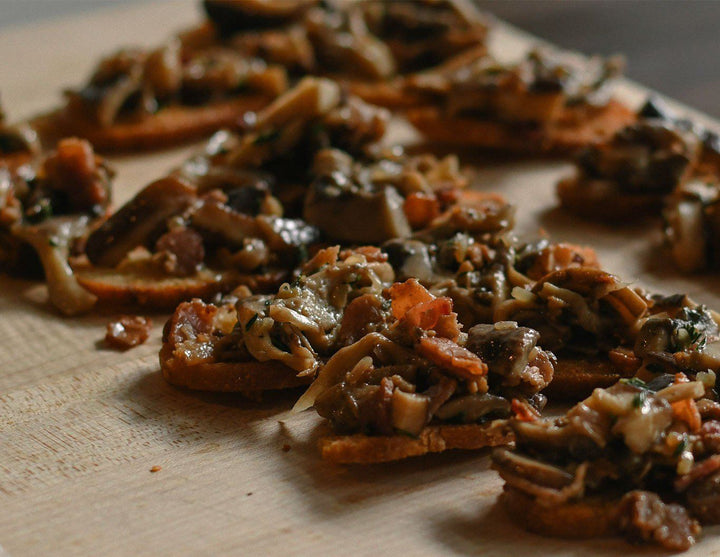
0;138;114;315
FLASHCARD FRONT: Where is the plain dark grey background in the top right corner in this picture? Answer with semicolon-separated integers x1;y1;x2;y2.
478;0;720;118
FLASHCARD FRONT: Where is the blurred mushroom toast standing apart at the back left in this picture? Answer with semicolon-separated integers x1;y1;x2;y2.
45;19;288;151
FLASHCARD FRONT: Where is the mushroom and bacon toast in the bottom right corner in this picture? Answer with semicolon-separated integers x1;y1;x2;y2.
493;373;720;551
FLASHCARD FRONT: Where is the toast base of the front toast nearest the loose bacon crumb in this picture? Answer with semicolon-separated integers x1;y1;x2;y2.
160;343;312;392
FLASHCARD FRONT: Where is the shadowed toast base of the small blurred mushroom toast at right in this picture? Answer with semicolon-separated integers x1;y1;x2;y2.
557;177;663;222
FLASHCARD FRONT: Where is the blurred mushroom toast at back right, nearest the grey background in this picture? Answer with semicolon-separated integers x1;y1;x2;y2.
407;50;635;153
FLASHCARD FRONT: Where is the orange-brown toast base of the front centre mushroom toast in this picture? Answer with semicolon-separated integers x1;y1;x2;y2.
320;420;513;464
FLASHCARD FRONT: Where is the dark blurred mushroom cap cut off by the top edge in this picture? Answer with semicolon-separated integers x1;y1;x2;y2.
203;0;319;36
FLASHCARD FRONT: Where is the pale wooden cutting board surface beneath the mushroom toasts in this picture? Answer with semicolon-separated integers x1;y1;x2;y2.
0;1;720;556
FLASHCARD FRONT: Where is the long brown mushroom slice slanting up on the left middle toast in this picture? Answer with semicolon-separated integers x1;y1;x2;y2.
86;177;197;267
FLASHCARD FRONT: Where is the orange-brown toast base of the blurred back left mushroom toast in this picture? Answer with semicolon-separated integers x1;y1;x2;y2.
36;95;272;151
